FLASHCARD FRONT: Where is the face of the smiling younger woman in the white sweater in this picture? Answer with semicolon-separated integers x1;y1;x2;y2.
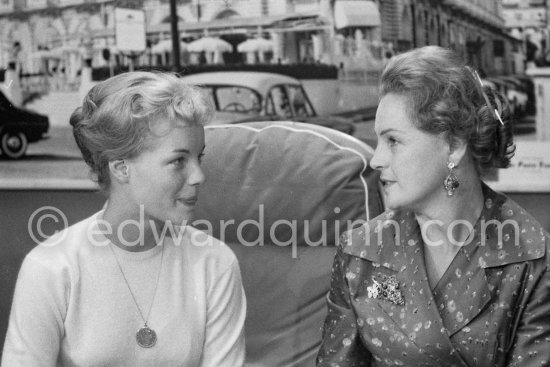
127;125;205;225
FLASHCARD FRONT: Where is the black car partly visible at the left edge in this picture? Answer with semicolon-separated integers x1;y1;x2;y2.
0;92;50;159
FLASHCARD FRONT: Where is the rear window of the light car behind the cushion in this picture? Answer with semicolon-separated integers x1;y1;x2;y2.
203;85;262;114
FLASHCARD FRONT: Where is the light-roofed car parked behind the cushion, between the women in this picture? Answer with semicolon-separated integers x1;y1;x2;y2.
179;71;355;134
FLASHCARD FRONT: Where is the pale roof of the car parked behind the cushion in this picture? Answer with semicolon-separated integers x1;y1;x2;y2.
182;71;300;95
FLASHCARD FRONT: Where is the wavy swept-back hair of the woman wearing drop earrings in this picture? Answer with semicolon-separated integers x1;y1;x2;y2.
380;46;515;174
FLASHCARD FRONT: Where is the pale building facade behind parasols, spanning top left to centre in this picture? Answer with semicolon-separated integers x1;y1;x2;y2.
0;0;386;75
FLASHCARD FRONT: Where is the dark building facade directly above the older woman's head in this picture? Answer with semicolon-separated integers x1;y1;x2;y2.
378;0;523;75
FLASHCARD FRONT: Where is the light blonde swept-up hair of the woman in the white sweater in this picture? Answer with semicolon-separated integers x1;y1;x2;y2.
70;72;213;193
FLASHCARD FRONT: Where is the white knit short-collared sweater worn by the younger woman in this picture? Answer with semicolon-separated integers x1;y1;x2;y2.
2;213;246;367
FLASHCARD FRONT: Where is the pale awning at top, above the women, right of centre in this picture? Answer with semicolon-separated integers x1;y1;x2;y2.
334;0;380;29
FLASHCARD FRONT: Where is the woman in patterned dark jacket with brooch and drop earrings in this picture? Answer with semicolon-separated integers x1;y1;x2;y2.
317;46;550;367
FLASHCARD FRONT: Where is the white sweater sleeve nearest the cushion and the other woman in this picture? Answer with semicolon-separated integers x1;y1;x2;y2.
200;259;246;367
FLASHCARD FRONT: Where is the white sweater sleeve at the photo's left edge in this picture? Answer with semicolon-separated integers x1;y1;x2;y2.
2;253;69;367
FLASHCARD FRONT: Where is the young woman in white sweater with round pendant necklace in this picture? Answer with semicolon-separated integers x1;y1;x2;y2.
2;72;246;367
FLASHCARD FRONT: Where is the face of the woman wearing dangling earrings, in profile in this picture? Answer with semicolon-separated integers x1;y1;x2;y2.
370;93;450;212
